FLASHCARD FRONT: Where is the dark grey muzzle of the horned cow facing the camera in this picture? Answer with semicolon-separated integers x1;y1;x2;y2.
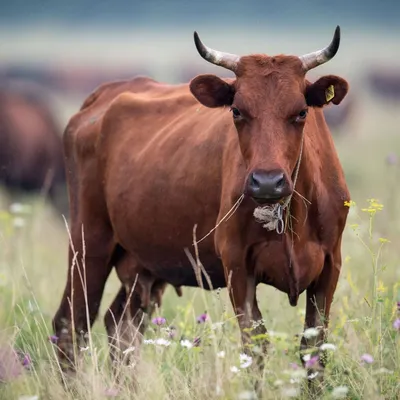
245;169;293;204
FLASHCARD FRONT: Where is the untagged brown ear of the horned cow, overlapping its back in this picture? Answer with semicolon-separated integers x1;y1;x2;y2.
189;75;235;108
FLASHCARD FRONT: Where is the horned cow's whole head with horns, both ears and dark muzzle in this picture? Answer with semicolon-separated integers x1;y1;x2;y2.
190;27;348;203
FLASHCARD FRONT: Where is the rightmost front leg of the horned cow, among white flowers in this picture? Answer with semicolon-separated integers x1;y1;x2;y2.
300;252;340;396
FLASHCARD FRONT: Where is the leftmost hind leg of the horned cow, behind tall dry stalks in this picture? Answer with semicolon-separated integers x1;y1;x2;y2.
53;223;114;372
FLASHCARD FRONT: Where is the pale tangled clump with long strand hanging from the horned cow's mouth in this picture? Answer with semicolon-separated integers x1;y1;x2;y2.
253;130;304;235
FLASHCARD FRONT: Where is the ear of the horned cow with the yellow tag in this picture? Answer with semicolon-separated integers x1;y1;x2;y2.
305;75;349;107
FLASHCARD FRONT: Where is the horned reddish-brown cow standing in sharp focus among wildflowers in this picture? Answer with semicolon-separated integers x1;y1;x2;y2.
53;27;349;396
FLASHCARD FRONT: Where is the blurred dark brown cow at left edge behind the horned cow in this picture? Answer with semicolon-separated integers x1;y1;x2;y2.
0;81;66;211
